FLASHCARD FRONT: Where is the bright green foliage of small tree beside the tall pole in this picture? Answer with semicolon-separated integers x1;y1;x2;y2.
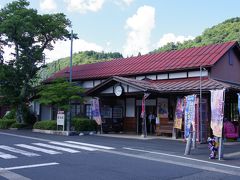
38;78;84;110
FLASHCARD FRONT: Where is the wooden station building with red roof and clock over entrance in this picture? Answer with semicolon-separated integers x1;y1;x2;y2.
38;42;240;141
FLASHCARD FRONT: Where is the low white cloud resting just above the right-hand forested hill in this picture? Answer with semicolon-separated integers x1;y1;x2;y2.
157;33;194;47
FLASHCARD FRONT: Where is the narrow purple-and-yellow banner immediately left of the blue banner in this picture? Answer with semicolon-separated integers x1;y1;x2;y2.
174;98;183;129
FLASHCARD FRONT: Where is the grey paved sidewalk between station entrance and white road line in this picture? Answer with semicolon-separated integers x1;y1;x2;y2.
96;134;240;168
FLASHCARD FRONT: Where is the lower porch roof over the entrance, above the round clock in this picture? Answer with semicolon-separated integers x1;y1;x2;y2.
86;76;240;96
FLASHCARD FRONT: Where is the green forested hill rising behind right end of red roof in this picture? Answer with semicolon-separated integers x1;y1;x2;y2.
150;17;240;53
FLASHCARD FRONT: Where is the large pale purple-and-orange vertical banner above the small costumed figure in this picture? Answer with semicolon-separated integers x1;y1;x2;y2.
211;89;224;137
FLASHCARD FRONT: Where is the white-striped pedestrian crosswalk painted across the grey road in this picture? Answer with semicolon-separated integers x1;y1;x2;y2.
0;141;115;160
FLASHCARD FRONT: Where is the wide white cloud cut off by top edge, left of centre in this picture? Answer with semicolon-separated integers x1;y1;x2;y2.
65;0;105;13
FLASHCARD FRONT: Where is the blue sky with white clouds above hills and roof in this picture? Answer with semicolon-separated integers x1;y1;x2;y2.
0;0;240;62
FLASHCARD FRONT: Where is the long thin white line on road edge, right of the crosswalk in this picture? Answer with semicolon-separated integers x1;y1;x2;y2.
123;147;240;169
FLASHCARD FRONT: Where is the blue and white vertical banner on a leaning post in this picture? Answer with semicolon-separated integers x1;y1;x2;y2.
184;95;196;138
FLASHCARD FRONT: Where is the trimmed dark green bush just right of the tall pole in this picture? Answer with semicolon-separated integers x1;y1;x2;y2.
72;118;97;132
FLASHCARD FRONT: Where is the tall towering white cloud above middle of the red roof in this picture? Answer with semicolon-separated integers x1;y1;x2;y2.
123;6;155;56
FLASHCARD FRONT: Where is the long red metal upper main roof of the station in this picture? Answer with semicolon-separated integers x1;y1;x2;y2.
48;41;238;81
